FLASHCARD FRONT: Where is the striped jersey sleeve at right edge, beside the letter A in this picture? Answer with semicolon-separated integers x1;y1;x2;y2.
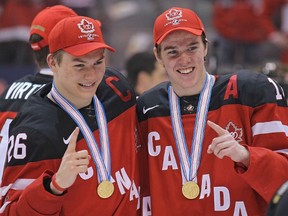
236;74;288;202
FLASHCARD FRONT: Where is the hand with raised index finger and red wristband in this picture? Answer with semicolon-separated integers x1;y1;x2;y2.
50;127;91;194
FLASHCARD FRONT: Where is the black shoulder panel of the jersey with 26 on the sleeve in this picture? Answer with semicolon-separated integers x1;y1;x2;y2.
8;85;75;166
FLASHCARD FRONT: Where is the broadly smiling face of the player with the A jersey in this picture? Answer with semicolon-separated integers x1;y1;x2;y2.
154;30;207;97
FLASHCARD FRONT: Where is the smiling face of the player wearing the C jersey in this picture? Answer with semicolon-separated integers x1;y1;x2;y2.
47;49;105;109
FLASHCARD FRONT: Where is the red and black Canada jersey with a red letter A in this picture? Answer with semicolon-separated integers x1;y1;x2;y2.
137;71;288;216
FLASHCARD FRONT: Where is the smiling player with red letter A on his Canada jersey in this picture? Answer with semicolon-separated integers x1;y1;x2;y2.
137;7;288;216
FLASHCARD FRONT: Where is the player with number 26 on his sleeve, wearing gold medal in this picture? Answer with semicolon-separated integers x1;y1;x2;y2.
0;16;140;216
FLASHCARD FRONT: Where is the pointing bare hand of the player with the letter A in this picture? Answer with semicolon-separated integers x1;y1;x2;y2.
207;121;250;167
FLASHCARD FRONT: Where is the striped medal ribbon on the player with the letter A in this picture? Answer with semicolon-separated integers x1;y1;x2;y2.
168;73;215;182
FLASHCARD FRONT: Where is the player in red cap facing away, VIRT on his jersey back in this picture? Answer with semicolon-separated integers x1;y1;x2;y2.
0;5;77;186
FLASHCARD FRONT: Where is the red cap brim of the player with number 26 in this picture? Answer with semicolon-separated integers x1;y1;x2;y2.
63;42;116;56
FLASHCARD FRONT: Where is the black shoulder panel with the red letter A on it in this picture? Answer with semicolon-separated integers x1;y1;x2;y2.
210;70;287;110
